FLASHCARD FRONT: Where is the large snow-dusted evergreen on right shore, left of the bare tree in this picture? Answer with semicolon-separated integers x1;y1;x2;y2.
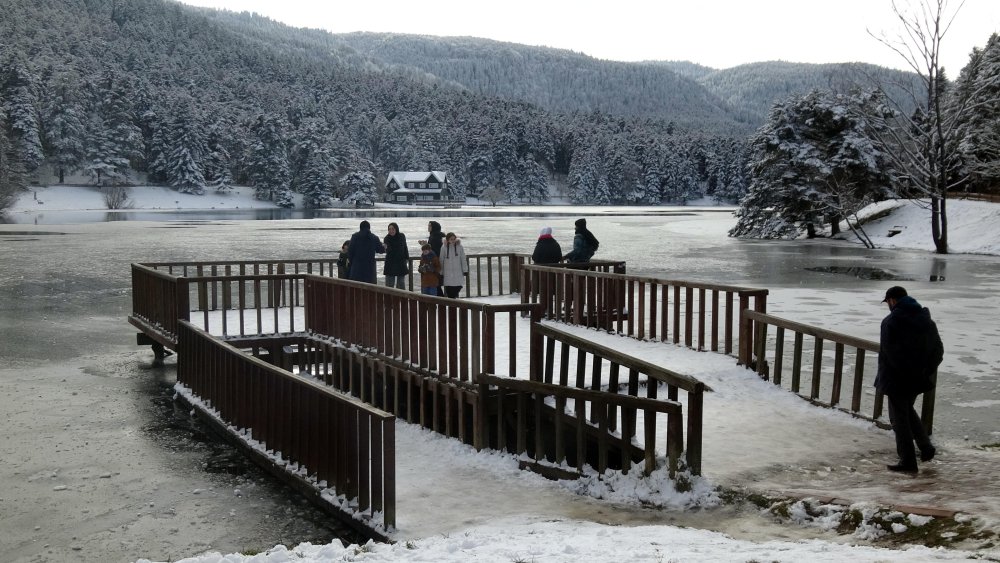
730;90;892;245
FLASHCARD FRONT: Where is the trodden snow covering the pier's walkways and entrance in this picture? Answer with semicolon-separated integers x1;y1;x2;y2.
193;296;1000;539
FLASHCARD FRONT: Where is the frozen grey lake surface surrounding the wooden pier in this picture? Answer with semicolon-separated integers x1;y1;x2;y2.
0;208;1000;559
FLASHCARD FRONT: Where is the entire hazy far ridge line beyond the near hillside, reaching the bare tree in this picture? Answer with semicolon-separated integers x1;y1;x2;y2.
333;32;917;132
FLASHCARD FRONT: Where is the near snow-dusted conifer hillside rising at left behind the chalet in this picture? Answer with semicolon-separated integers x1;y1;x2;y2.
0;0;745;206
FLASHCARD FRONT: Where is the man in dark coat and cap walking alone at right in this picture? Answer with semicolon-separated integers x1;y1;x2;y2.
875;286;944;473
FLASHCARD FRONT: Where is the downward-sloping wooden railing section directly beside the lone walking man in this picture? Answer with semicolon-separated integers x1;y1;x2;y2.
747;311;935;434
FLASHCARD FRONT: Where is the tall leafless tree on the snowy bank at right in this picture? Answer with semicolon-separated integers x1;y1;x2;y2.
868;0;965;254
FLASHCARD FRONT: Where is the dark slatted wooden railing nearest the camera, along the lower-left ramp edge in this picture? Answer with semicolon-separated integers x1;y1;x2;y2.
177;322;396;530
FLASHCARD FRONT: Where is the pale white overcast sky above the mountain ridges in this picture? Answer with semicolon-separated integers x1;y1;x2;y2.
182;0;1000;78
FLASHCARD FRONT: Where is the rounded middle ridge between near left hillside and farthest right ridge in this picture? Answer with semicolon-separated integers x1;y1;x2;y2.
320;33;752;134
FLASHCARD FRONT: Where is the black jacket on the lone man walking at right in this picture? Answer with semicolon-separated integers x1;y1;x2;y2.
875;296;944;395
